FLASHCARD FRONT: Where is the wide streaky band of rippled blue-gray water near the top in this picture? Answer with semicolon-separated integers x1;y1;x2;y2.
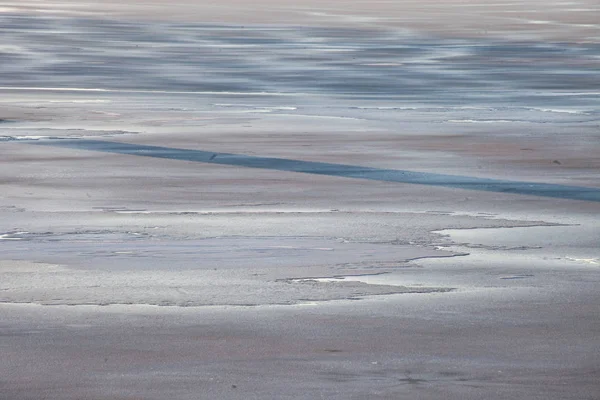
0;13;600;107
